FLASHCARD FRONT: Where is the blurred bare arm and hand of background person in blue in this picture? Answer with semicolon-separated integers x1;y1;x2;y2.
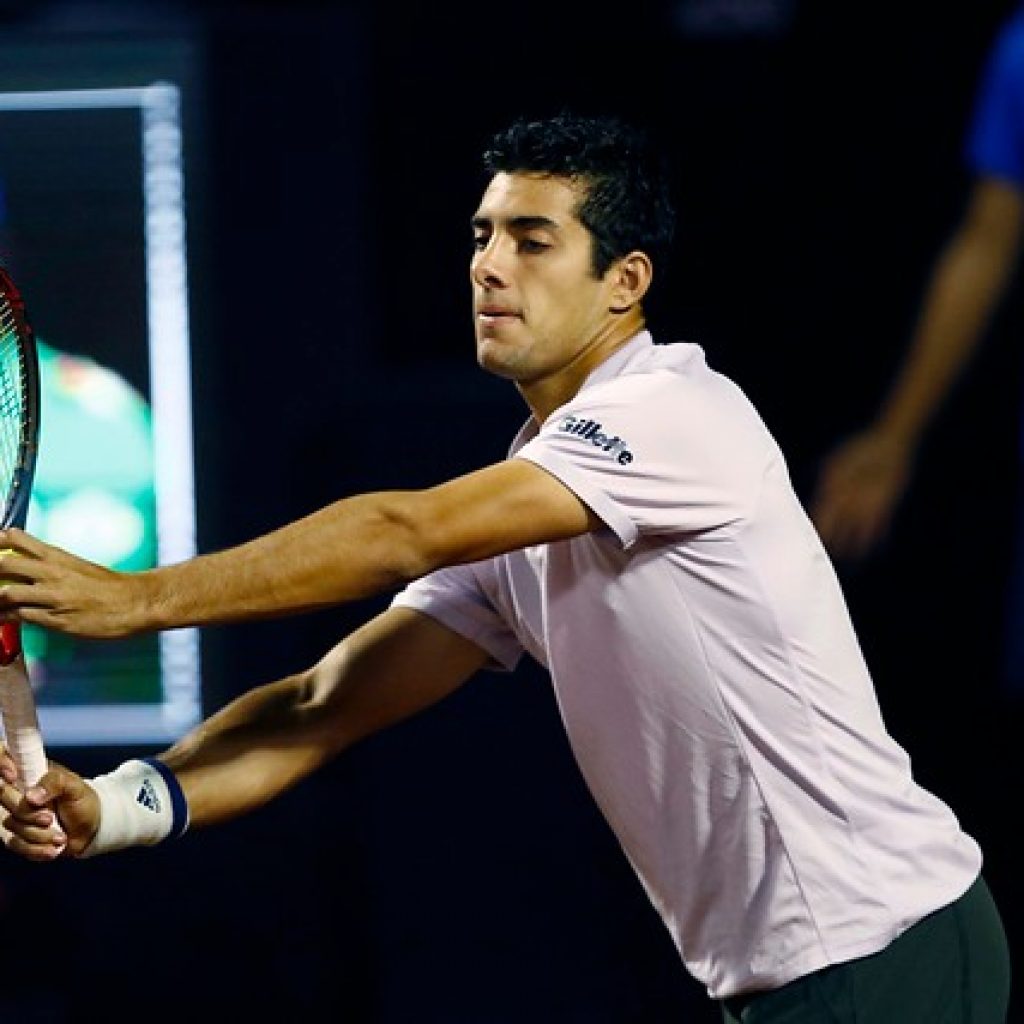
811;178;1024;556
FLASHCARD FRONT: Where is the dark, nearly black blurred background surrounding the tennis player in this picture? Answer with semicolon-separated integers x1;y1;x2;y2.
0;0;1024;1024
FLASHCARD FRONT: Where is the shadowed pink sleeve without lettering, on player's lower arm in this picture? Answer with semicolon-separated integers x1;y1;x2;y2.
391;562;523;672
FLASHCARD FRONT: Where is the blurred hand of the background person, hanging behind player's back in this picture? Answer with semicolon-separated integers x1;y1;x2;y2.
811;430;913;558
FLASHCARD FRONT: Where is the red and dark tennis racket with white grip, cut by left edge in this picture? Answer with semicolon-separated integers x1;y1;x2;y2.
0;267;46;792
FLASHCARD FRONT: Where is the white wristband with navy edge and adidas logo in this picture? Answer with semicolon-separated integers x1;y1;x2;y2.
79;758;188;858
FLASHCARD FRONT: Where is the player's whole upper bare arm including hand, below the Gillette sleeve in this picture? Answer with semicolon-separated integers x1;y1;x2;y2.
0;459;600;637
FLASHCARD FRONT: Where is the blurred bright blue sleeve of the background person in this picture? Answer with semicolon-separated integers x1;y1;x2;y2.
966;15;1024;187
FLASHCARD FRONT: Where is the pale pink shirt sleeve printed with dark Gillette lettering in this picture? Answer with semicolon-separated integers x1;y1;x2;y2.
515;371;781;547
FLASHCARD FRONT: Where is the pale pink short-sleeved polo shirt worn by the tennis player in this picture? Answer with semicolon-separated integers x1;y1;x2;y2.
395;332;981;998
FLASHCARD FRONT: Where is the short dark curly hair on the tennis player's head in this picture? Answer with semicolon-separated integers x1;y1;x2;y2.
483;113;676;276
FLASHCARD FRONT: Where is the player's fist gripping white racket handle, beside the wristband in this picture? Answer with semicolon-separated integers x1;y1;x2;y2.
0;746;99;861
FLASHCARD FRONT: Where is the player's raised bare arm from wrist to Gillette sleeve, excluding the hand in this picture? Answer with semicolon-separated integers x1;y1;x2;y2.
135;460;599;632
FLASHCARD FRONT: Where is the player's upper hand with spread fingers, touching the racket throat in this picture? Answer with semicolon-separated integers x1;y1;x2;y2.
0;528;142;638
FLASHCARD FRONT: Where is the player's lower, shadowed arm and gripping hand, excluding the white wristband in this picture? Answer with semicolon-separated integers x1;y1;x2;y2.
0;608;487;860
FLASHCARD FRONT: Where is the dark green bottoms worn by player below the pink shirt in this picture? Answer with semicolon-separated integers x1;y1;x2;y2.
722;879;1010;1024
